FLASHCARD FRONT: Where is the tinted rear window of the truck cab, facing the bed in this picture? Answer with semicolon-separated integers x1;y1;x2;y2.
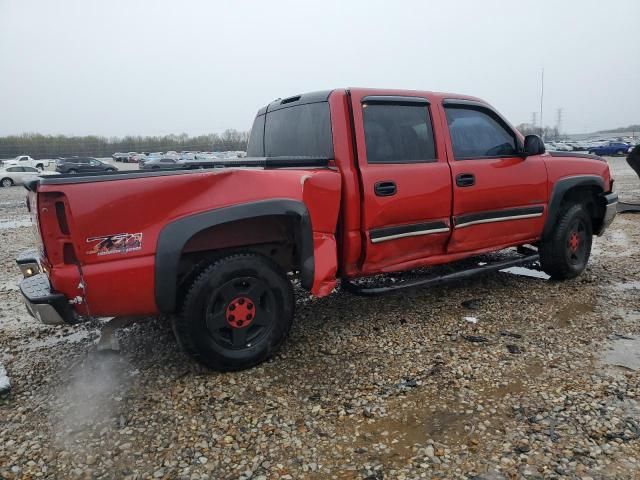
247;102;333;158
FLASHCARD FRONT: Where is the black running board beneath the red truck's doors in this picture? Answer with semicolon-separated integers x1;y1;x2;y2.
341;250;540;296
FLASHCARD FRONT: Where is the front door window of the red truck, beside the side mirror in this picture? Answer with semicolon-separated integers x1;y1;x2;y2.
445;106;517;160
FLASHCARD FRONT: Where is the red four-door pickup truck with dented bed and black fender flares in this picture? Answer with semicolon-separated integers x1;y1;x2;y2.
17;88;617;370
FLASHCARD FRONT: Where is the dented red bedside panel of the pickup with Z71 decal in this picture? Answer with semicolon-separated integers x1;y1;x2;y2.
38;169;340;316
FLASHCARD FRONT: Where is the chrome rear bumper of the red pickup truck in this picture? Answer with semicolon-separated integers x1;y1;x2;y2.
16;252;78;325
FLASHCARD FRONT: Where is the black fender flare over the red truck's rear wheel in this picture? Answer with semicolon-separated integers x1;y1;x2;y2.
155;198;315;313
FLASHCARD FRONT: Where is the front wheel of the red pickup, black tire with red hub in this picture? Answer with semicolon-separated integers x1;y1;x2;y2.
539;204;593;280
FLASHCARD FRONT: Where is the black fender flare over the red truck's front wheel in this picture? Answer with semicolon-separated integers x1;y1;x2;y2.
542;175;604;240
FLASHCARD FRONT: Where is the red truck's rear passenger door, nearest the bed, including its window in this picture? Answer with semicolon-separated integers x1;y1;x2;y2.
351;89;451;273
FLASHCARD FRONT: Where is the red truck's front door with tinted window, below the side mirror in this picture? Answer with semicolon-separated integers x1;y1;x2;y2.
441;99;548;253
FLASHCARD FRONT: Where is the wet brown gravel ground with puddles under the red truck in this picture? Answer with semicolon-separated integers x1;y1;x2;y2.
0;159;640;480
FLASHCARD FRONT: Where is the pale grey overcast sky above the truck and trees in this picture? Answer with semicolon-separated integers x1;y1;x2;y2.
0;0;640;136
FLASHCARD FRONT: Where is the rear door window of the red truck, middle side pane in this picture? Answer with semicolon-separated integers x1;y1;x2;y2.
362;101;436;163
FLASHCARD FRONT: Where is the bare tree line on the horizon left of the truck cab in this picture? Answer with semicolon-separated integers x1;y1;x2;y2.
0;129;249;158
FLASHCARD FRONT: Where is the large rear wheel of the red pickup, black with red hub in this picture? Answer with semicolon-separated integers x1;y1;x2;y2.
173;253;294;371
